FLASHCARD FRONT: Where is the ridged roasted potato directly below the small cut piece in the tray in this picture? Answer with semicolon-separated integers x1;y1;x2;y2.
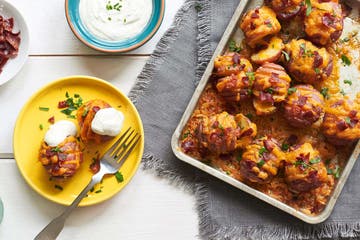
253;63;291;115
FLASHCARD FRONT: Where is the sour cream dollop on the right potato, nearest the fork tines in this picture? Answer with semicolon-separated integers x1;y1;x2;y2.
91;108;124;137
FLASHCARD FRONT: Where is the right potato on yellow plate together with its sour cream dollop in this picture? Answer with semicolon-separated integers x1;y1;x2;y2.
76;99;124;143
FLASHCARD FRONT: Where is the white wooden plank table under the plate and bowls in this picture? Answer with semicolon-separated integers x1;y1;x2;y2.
0;0;198;240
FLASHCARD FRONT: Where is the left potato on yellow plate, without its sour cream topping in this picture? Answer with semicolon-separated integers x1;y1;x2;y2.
39;136;83;179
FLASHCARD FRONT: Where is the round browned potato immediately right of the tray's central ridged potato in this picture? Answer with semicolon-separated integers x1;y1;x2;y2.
284;84;324;127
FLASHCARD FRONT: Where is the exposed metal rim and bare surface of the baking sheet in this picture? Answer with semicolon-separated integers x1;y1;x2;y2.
171;0;360;224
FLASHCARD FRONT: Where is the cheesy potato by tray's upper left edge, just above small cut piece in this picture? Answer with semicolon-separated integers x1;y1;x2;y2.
240;6;281;48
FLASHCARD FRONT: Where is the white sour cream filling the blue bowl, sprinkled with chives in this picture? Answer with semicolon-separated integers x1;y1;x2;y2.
79;0;153;42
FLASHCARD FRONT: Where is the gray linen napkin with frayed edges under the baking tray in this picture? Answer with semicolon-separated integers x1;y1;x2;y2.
130;0;360;240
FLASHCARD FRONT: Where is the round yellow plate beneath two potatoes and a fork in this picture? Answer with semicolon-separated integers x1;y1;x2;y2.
13;76;144;206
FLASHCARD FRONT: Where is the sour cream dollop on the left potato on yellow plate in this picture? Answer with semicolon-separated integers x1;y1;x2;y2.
44;120;77;147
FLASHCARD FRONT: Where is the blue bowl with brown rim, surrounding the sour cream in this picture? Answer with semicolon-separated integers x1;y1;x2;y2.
65;0;165;53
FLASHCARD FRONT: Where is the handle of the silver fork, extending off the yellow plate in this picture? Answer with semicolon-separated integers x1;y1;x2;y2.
34;169;105;240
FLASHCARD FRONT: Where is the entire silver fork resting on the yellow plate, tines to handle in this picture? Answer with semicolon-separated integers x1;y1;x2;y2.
34;127;141;240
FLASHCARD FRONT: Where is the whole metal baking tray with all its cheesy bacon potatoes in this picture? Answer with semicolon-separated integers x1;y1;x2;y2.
172;0;360;224
